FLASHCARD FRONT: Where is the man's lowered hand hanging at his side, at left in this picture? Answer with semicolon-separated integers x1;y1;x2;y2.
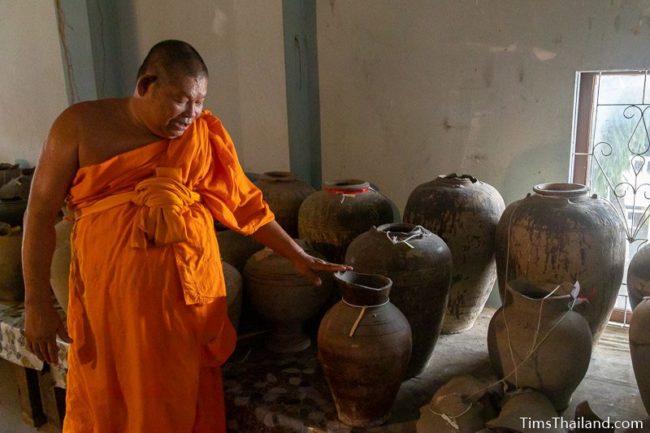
25;303;71;365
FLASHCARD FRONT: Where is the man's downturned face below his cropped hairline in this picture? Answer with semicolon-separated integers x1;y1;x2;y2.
143;71;208;138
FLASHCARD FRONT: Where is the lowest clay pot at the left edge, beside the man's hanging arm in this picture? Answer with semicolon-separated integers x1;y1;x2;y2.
0;223;25;301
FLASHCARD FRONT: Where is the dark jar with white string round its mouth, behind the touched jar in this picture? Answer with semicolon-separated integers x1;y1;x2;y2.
345;223;452;377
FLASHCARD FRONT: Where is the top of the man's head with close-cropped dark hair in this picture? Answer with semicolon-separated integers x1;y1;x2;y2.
138;39;208;84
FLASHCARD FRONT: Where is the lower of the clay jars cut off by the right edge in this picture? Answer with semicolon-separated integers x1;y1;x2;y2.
630;297;650;413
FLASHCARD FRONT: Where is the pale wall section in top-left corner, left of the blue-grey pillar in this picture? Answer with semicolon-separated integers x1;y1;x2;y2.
0;0;68;165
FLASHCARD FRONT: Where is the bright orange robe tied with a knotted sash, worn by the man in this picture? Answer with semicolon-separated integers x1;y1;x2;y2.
63;112;273;433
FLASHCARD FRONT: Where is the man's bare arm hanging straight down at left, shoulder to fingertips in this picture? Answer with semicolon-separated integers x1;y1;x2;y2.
22;109;78;364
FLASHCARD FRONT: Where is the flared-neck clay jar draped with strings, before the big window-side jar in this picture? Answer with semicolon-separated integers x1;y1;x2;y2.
488;280;592;411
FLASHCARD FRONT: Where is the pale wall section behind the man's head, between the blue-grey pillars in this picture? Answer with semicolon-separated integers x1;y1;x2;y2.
101;0;289;172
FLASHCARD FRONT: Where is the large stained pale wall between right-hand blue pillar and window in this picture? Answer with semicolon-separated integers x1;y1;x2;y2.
318;0;650;209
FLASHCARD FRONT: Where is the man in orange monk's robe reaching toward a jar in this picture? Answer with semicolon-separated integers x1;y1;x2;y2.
23;40;349;433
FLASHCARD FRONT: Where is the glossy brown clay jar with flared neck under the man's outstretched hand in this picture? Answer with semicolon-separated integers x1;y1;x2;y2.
318;271;411;427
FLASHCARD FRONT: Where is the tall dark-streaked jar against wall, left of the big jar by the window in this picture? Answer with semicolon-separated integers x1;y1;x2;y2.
404;174;505;334
